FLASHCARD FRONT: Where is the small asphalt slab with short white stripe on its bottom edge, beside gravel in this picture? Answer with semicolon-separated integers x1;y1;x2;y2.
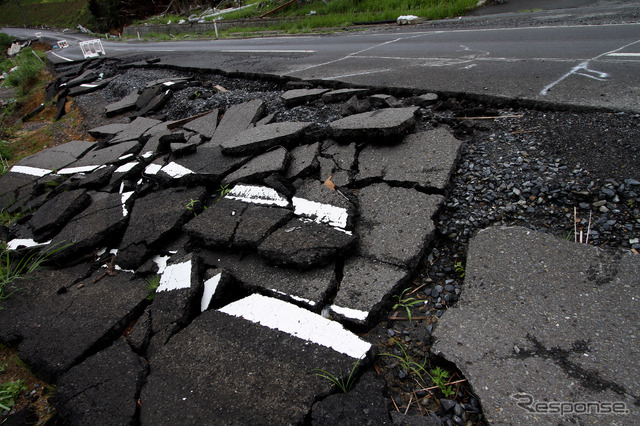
331;256;410;324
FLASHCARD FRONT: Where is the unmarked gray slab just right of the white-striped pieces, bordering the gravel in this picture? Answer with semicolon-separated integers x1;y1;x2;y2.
356;183;444;269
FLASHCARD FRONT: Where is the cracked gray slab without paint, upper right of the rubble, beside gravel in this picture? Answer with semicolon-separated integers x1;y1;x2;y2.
356;129;462;191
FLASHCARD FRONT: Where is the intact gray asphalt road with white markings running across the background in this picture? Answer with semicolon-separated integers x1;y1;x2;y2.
2;20;640;112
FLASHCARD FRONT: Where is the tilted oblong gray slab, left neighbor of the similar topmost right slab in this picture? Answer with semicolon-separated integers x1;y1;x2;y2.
221;122;312;155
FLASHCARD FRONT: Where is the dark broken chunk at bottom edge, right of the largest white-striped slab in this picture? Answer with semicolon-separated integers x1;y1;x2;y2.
311;371;391;425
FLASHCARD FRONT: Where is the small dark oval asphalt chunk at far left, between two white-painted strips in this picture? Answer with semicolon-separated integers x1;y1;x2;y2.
29;189;91;242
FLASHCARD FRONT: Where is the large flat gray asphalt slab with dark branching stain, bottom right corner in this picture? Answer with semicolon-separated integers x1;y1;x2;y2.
433;227;640;425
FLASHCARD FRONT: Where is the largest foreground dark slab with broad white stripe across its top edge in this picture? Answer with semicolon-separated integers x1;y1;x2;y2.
140;295;370;424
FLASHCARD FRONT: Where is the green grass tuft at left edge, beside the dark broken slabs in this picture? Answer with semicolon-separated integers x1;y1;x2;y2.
0;243;71;309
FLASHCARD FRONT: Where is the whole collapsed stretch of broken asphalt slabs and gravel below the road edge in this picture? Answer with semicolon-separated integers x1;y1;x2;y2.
0;60;640;424
